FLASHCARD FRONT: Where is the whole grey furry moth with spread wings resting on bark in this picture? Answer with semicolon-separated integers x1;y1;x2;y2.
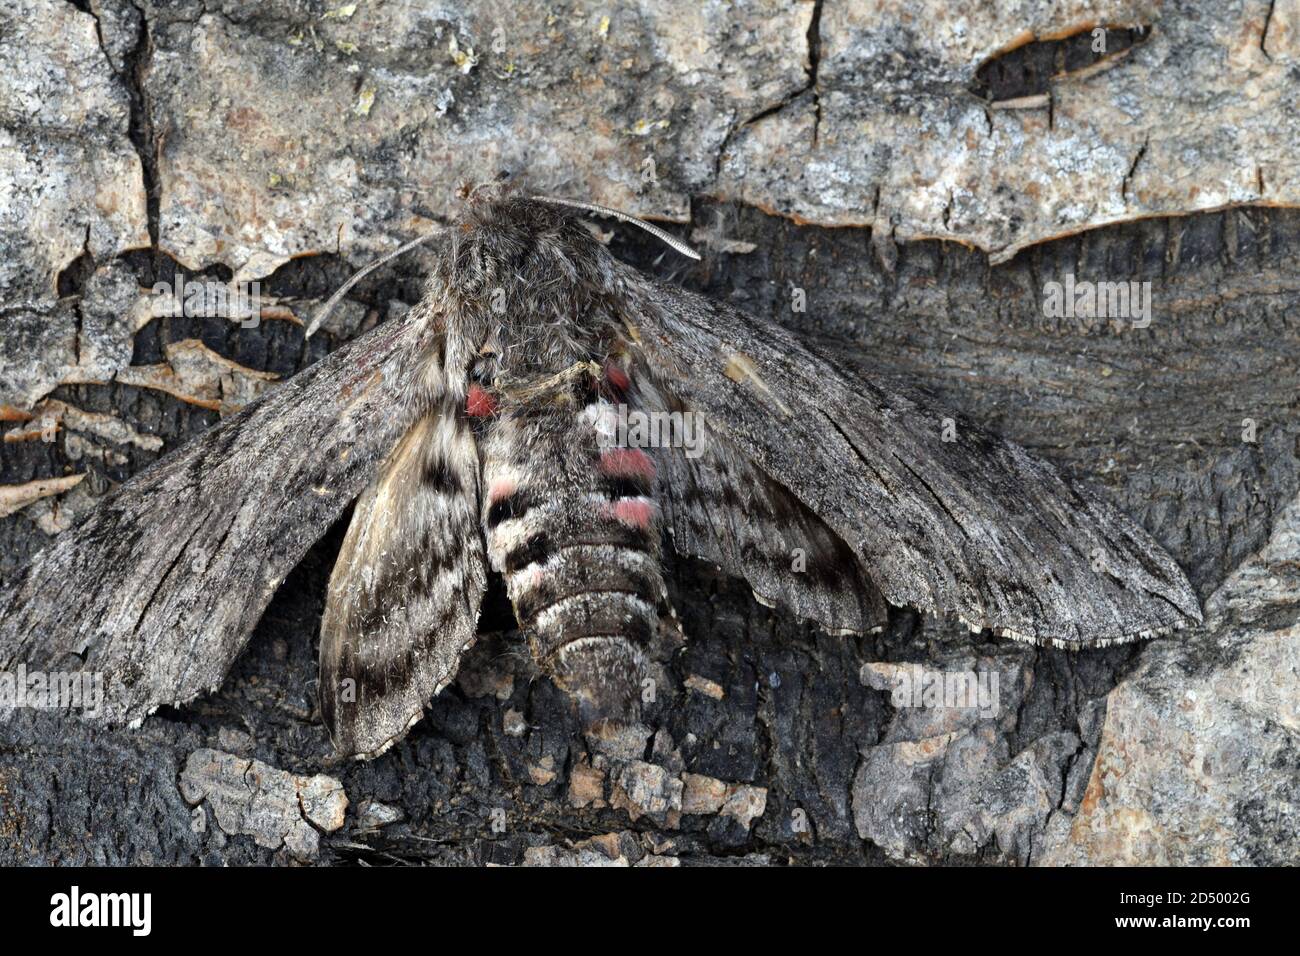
0;189;1201;757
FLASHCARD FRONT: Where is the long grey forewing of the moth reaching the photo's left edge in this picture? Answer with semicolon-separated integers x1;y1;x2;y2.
0;314;420;722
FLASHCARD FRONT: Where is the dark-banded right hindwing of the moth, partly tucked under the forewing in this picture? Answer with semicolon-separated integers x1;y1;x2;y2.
633;377;888;633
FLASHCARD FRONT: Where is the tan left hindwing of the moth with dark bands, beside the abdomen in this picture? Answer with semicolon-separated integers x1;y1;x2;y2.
320;412;486;758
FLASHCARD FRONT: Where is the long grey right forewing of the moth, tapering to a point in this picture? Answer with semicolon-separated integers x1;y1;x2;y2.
624;277;1201;648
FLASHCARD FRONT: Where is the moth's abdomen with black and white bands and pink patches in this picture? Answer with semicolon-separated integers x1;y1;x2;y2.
480;377;667;719
